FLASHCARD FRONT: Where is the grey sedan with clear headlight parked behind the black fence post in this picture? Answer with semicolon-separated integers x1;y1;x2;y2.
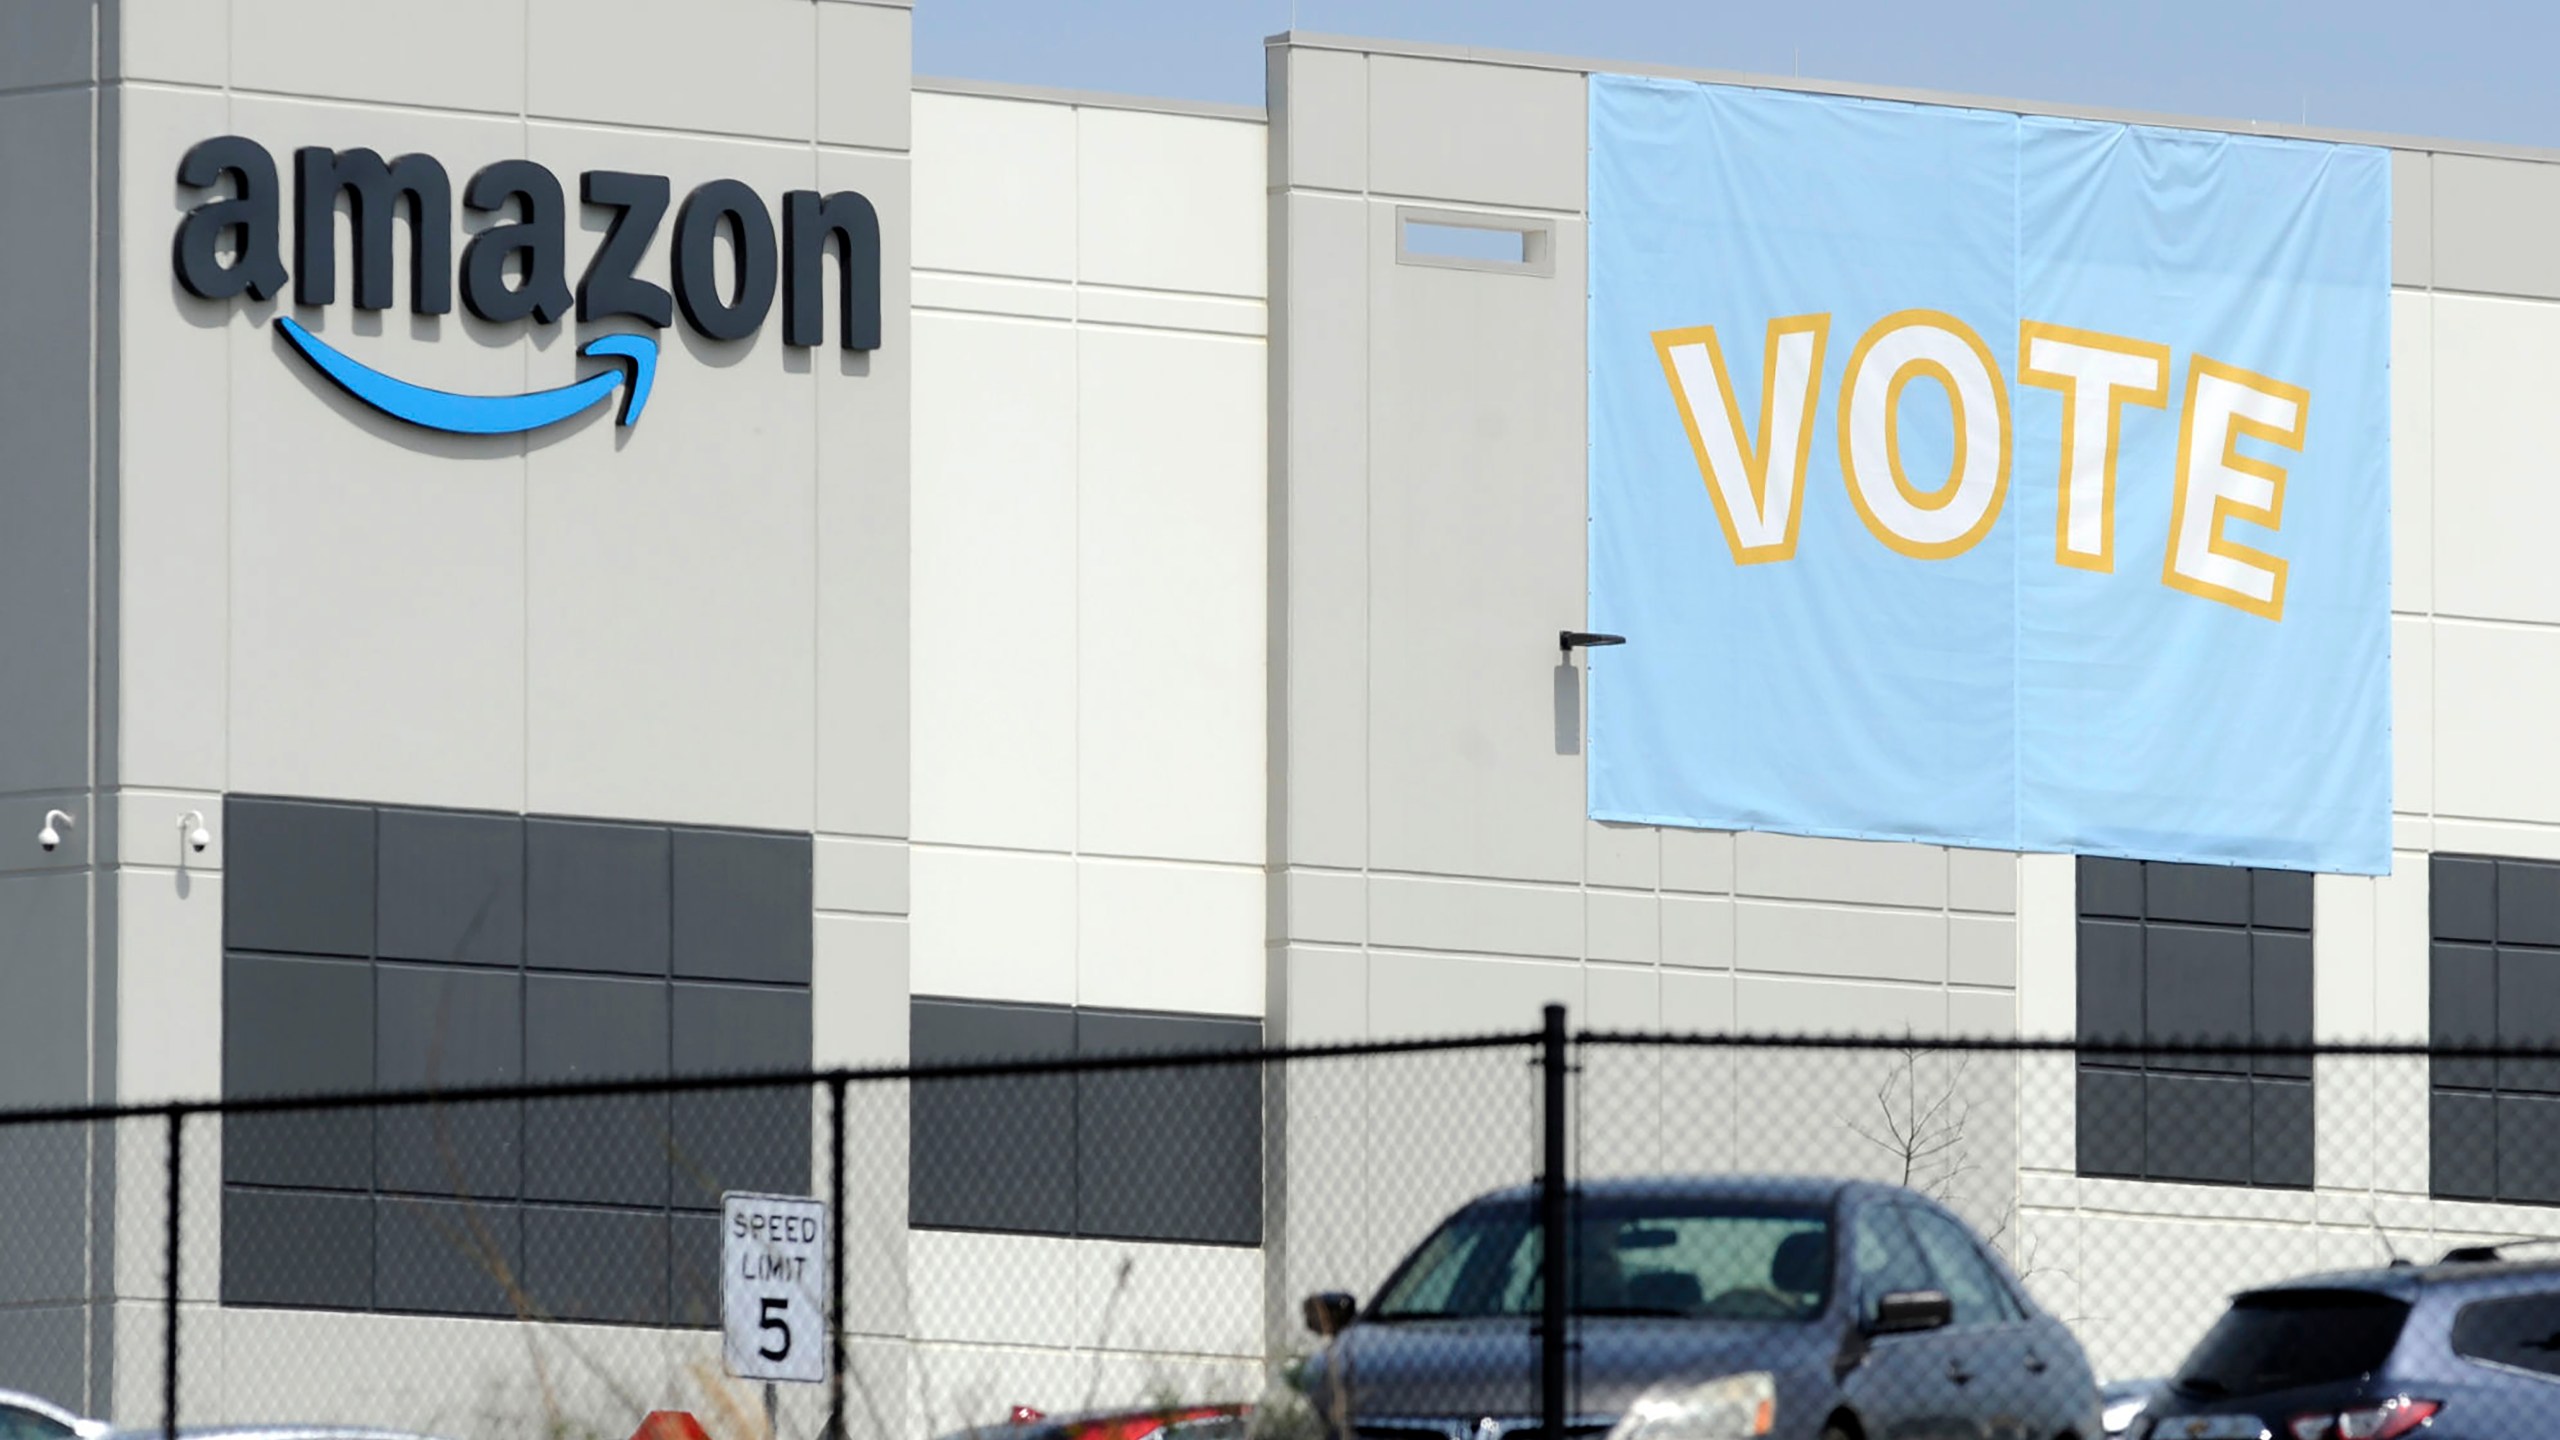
1306;1176;2099;1440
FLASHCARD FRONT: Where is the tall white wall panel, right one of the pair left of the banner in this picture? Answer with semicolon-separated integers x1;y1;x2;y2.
1075;331;1267;863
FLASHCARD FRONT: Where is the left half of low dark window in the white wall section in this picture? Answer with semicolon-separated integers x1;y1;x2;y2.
906;999;1075;1235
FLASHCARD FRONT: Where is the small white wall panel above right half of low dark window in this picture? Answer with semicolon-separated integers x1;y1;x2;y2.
1075;858;1262;1015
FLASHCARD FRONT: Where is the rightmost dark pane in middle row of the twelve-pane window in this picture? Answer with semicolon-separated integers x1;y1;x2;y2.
673;984;812;1207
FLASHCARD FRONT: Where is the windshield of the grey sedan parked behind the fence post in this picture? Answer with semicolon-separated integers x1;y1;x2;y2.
1367;1197;1830;1320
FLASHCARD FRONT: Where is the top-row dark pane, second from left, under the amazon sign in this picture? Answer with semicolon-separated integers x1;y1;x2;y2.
374;810;525;966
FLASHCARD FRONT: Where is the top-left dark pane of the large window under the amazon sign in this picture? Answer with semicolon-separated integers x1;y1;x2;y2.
223;797;374;956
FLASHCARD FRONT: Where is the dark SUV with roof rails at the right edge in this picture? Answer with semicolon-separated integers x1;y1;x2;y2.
2132;1248;2560;1440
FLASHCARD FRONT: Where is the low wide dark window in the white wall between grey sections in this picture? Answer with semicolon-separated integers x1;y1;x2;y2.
906;997;1262;1245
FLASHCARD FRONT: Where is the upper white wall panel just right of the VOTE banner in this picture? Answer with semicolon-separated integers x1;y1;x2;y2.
2432;295;2560;623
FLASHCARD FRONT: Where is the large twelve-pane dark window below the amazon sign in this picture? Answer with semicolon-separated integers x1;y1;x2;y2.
220;797;812;1325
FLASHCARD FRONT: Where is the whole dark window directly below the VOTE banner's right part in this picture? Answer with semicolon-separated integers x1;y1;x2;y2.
2079;856;2312;1189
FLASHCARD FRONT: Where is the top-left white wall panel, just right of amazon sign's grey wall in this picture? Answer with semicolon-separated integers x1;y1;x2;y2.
909;92;1075;280
